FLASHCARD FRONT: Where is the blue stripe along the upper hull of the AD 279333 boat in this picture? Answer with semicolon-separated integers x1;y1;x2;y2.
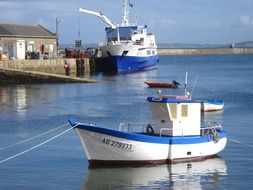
76;124;227;144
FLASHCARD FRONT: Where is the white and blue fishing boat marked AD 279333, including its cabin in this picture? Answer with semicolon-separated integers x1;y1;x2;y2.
69;97;227;166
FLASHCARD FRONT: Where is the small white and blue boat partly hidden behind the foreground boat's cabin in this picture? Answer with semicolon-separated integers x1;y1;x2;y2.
200;99;224;112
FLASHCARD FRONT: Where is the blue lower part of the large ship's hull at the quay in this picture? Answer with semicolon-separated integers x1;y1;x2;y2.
96;55;159;72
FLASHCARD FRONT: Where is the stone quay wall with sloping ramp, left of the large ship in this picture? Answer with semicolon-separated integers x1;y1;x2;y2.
0;58;95;84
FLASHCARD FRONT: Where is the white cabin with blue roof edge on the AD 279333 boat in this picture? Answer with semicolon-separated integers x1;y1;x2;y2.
147;97;201;136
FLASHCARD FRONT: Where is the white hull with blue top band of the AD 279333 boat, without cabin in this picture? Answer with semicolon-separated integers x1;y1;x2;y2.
75;124;227;166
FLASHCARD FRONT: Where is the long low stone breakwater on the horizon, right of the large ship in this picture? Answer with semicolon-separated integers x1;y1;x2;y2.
158;48;253;55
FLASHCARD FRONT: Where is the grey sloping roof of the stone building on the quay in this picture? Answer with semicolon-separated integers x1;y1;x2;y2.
0;24;56;38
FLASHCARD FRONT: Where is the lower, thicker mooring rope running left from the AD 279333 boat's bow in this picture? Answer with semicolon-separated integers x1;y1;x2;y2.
0;124;78;164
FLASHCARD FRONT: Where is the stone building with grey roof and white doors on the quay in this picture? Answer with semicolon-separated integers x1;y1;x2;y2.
0;24;58;60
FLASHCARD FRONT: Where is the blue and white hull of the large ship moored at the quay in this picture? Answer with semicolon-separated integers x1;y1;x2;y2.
97;42;159;72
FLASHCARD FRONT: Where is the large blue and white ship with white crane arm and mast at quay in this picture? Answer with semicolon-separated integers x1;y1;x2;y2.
79;0;159;72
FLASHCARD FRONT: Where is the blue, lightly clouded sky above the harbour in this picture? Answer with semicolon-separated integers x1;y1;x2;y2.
0;0;253;44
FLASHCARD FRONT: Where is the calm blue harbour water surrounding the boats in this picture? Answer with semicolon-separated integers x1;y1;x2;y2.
0;55;253;189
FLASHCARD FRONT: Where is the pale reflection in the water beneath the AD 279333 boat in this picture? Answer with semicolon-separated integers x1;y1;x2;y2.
82;157;227;189
